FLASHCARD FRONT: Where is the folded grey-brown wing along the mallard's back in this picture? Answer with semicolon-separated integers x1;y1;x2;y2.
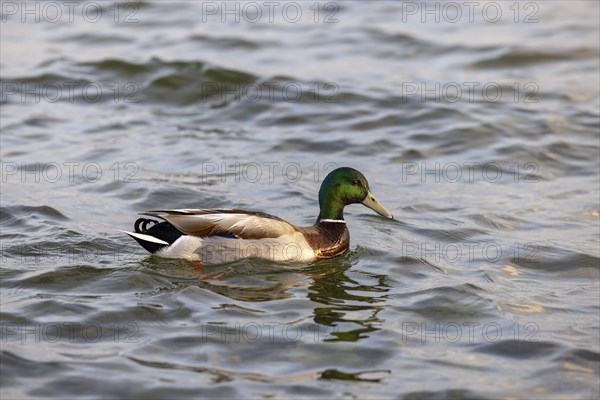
142;209;297;239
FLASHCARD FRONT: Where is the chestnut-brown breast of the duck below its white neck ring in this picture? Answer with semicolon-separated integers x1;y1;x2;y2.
298;221;350;258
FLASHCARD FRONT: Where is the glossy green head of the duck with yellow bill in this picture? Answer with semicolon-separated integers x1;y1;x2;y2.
317;167;393;221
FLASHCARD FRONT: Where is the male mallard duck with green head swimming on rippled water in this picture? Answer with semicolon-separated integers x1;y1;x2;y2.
125;167;393;264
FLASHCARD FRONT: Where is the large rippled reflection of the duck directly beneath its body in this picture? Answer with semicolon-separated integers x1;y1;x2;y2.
143;254;390;342
